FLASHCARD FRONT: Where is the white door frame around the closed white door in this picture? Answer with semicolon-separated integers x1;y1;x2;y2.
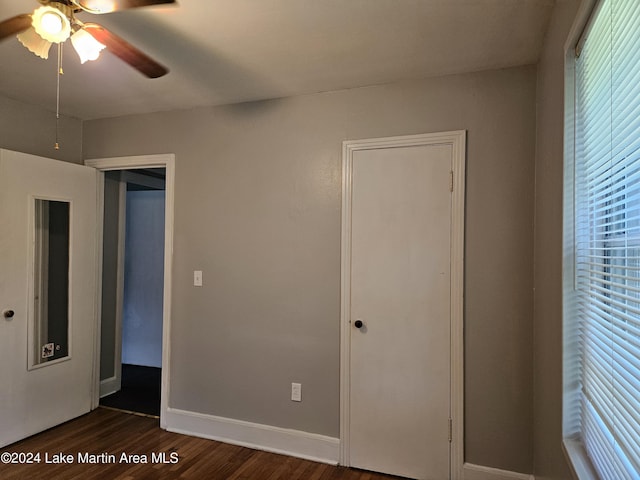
340;130;466;480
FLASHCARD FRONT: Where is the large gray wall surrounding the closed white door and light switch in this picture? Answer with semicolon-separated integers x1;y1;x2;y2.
83;67;536;472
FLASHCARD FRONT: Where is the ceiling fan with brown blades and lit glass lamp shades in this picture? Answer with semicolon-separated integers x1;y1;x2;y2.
0;0;175;78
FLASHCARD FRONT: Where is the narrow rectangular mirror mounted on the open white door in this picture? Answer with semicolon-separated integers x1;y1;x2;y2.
29;198;71;368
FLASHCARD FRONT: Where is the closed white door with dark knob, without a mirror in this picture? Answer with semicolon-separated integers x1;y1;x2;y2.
349;145;452;480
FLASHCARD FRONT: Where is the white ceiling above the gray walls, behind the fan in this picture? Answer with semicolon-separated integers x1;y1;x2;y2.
0;0;554;119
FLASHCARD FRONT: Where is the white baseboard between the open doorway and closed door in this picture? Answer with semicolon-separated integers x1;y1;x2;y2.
165;408;340;465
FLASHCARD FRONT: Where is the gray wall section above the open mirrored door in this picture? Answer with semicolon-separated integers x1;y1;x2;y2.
0;95;82;163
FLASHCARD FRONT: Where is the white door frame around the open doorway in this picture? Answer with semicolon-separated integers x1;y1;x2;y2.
84;154;175;429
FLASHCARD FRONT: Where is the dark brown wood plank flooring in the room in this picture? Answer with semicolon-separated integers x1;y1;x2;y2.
0;408;408;480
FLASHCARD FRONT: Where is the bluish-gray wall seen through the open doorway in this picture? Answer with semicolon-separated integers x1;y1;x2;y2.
122;190;165;367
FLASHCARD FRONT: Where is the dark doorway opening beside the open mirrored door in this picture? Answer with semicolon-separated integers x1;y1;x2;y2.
100;168;166;417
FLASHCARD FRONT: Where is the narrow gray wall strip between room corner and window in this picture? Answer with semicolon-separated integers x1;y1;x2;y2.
534;0;580;480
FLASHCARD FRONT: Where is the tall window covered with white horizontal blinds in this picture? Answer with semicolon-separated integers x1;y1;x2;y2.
564;0;640;480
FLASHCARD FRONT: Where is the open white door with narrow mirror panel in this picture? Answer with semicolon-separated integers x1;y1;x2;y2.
0;150;97;446
